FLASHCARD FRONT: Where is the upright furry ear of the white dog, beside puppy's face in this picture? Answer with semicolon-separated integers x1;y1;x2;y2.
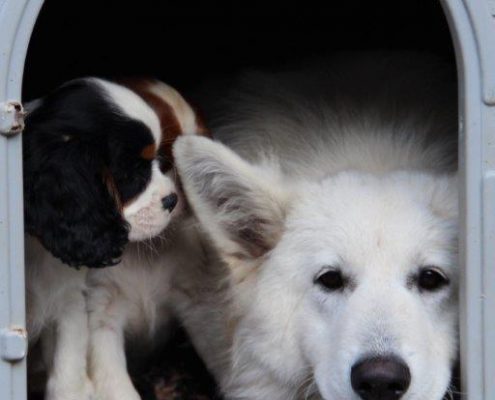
174;136;287;260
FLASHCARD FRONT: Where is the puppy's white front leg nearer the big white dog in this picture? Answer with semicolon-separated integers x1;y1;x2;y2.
89;287;141;400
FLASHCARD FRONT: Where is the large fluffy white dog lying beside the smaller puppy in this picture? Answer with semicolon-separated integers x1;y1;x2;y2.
174;55;458;400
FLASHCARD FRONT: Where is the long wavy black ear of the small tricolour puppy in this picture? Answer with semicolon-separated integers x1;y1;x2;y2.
23;81;128;267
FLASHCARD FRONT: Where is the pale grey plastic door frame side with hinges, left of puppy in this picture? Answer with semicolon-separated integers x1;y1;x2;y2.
0;0;42;400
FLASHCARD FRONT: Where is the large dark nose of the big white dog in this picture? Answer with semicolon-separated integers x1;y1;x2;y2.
351;357;411;400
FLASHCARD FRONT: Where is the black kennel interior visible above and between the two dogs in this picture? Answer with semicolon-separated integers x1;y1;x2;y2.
23;0;454;400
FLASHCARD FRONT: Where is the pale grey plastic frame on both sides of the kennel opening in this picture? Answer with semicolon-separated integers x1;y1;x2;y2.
0;0;495;400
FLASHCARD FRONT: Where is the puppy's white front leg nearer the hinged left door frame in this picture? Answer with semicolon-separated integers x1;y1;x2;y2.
41;290;94;400
